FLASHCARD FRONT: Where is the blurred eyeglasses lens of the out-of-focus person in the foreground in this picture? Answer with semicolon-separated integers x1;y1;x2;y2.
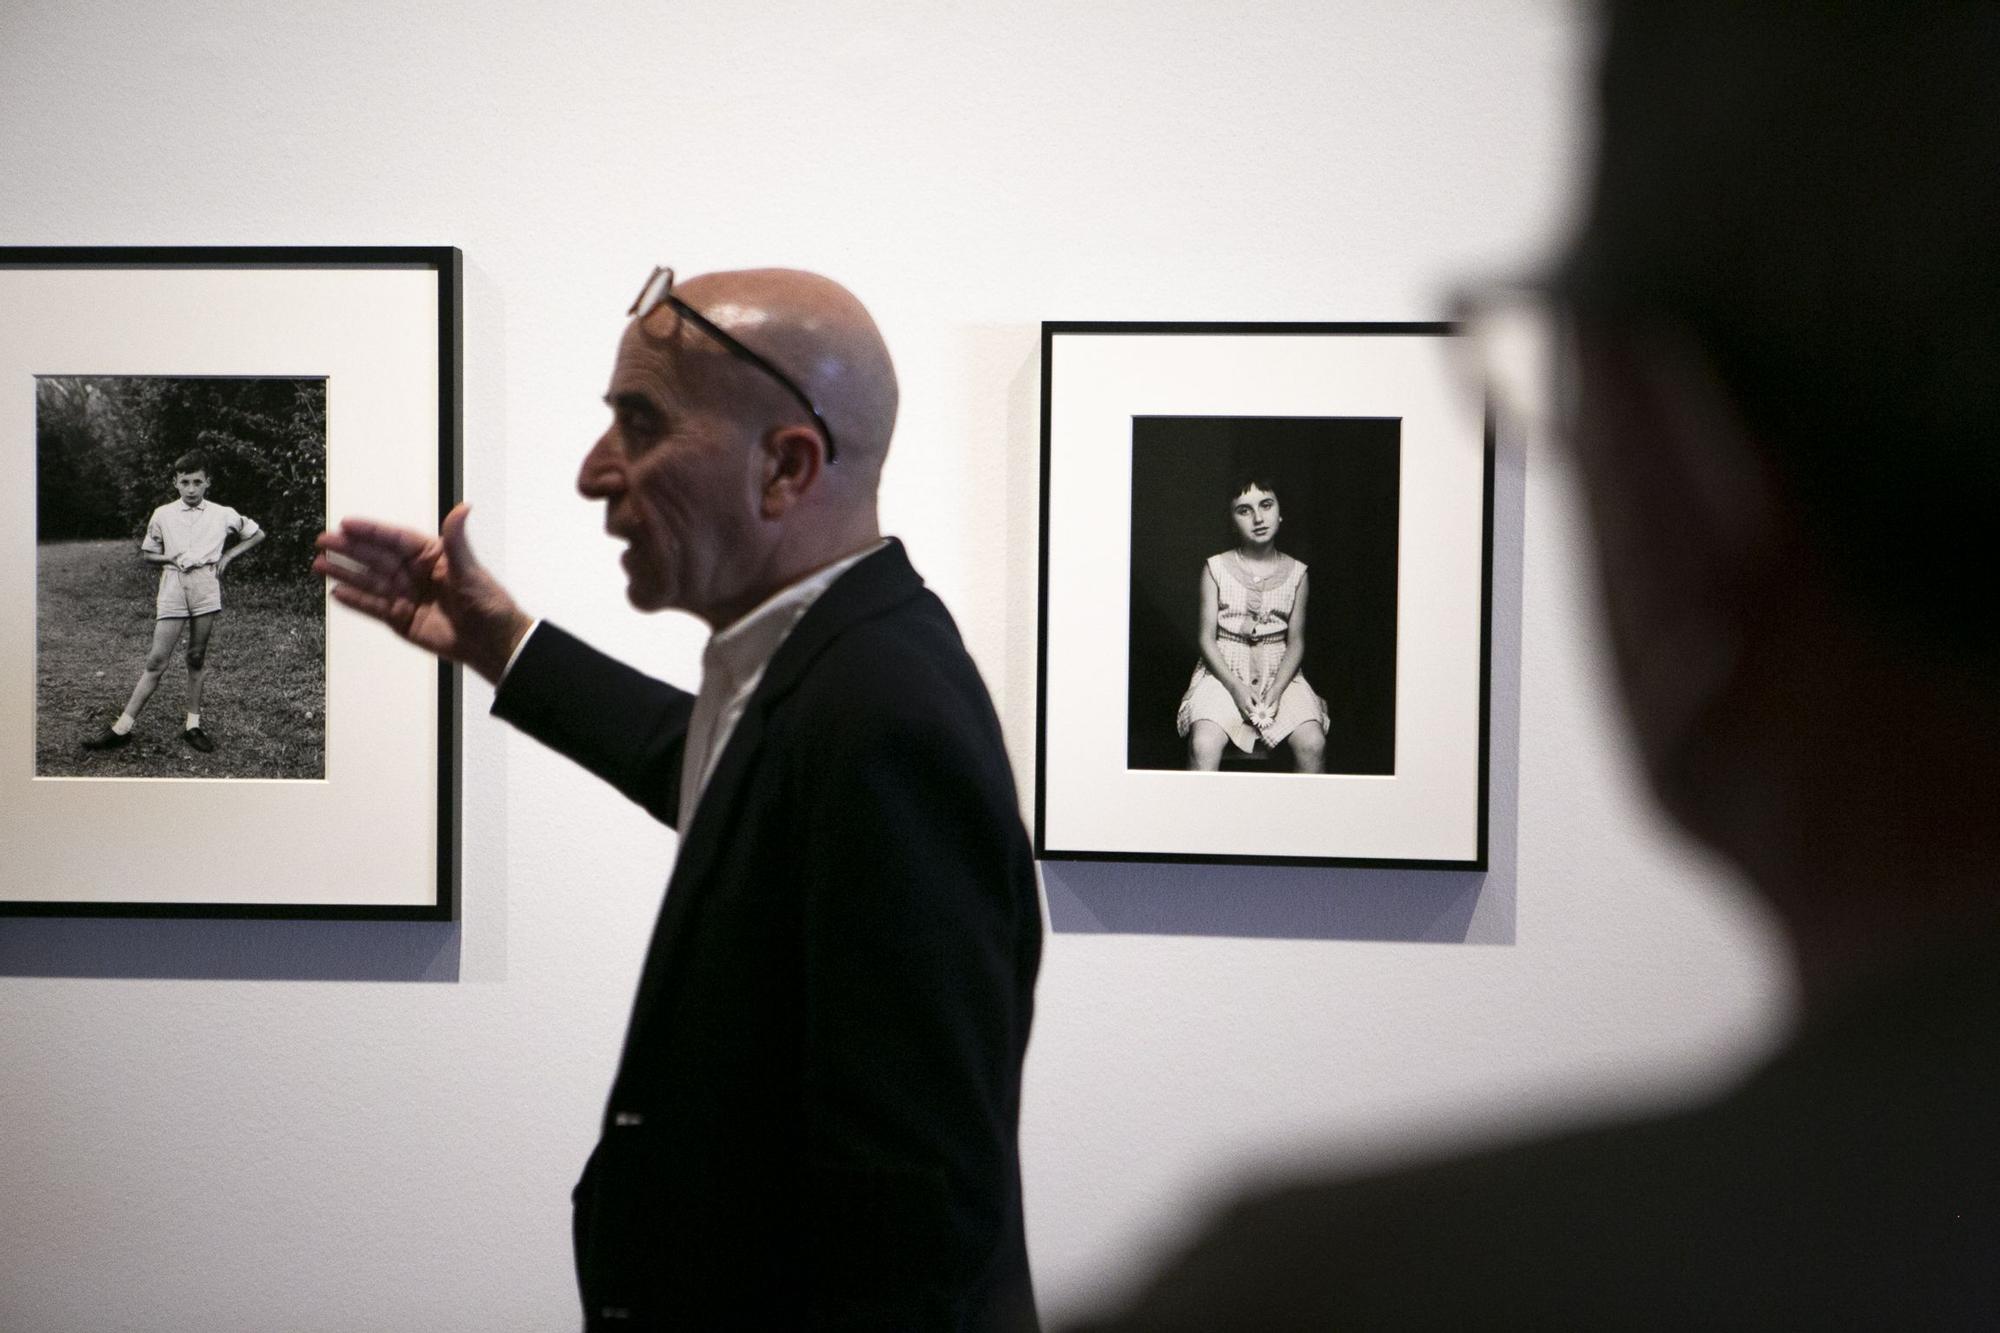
1454;286;1576;448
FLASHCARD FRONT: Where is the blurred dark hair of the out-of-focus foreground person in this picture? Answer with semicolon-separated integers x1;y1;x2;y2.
1562;0;2000;675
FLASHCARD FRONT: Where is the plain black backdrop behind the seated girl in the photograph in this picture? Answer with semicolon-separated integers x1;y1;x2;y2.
1126;416;1402;773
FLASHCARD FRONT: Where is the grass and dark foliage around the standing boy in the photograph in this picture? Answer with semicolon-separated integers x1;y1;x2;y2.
34;374;326;779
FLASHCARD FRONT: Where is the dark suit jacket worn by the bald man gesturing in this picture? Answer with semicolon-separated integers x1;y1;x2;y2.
494;542;1042;1329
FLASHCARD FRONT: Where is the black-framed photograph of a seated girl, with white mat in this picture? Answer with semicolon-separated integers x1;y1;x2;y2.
1036;322;1492;869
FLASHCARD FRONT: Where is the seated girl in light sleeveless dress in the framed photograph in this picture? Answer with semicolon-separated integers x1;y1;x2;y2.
1176;476;1326;773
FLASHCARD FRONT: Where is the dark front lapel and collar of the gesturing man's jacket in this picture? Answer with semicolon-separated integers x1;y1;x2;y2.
616;536;924;1025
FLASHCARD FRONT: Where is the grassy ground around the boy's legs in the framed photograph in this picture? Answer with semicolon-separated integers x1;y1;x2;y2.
34;540;326;779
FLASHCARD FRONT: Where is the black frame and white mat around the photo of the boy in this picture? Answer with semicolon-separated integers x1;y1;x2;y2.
0;246;464;921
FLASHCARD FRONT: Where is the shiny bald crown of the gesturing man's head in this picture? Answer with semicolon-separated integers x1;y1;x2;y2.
642;268;898;480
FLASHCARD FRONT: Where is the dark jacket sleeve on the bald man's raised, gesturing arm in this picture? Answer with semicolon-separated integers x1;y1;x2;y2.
492;620;694;827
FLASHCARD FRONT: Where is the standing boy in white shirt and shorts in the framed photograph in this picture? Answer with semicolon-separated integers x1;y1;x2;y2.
84;454;264;755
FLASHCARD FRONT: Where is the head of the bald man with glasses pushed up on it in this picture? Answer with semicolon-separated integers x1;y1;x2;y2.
576;268;896;628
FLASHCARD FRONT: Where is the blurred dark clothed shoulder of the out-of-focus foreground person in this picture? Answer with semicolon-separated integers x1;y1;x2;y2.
1092;924;2000;1333
